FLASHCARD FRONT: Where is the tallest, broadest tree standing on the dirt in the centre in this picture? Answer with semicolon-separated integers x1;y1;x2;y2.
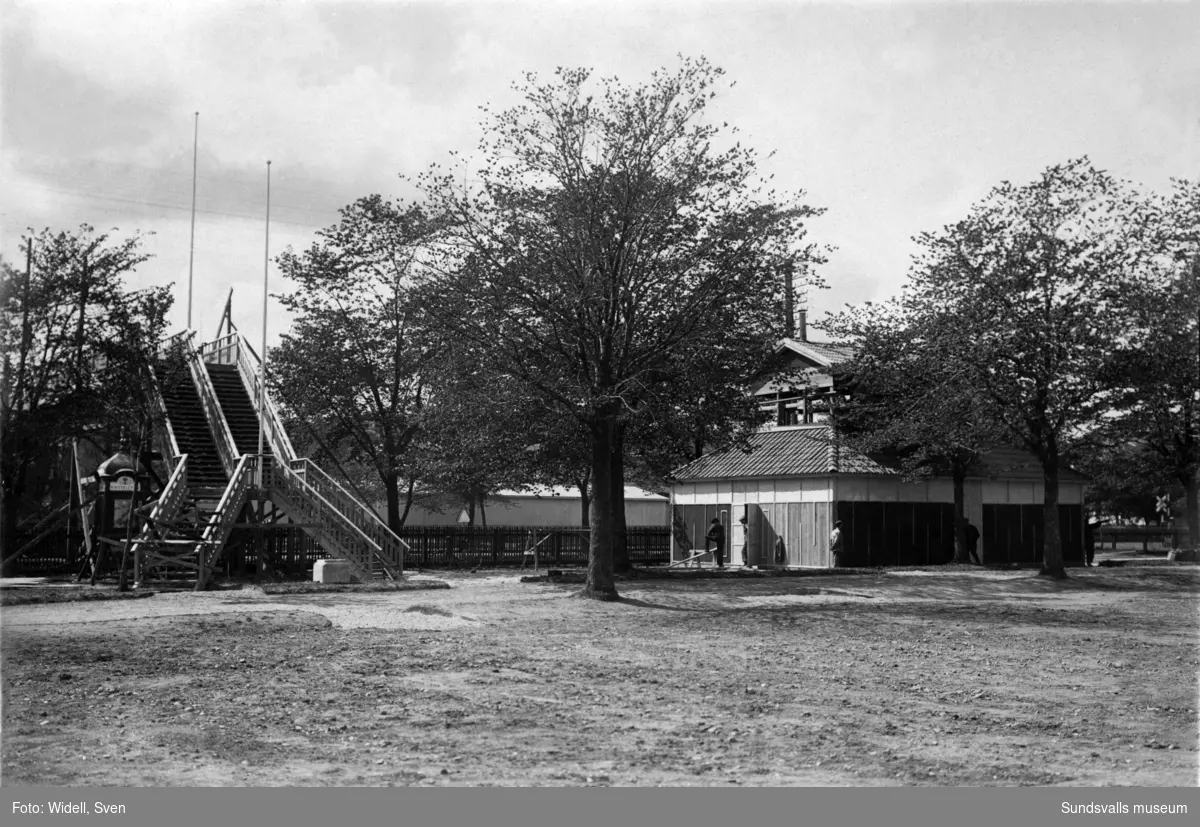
421;60;815;599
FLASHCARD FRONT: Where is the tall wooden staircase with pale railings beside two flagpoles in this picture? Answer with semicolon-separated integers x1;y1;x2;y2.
133;334;407;589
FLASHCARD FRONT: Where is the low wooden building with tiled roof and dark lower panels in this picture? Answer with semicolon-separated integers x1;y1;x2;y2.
671;424;1087;567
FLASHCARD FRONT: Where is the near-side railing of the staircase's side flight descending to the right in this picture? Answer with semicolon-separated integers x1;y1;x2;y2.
264;462;400;580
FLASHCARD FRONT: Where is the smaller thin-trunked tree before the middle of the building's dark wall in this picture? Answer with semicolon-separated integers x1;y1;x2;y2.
822;292;998;563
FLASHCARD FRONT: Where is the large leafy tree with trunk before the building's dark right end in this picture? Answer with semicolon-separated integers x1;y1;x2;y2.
825;158;1157;576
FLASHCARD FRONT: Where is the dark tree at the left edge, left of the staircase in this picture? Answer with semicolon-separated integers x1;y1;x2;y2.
0;224;172;561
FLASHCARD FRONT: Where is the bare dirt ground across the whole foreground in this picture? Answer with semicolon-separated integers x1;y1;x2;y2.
0;567;1200;786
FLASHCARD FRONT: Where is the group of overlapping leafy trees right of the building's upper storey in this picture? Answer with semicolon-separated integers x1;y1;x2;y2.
828;158;1200;576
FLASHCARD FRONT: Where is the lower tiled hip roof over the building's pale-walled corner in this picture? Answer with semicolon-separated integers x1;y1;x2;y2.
674;425;893;481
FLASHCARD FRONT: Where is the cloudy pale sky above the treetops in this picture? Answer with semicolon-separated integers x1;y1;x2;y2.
0;0;1200;341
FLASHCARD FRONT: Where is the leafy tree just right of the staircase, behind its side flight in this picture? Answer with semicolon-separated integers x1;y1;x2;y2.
270;196;439;531
